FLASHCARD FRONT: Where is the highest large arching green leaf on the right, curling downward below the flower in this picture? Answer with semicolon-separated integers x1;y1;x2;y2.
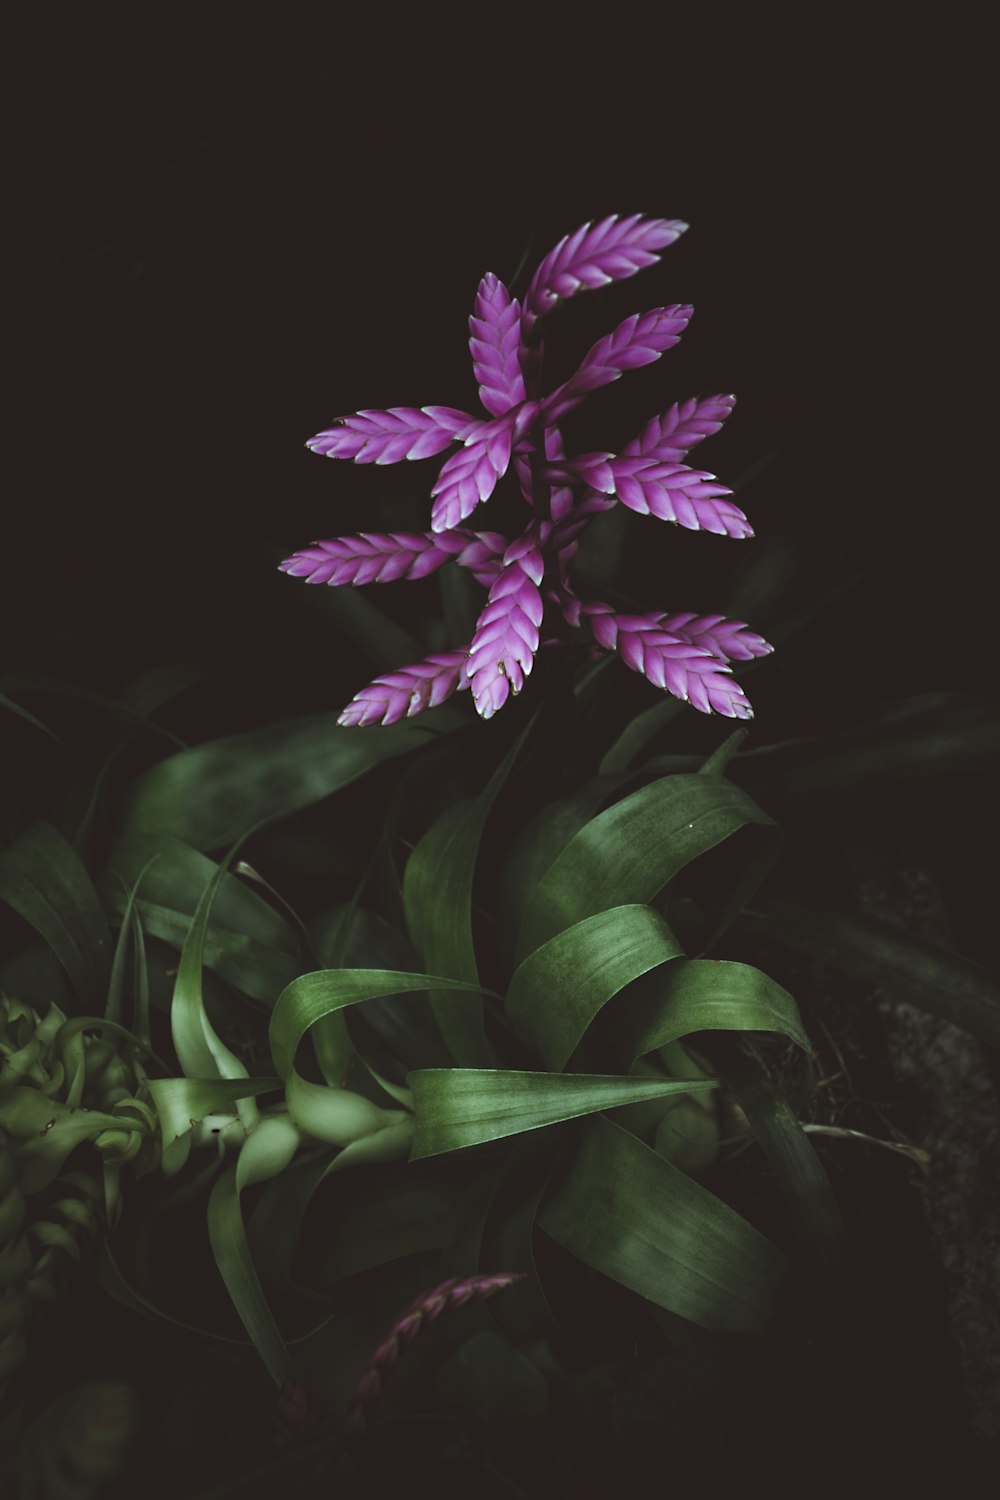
519;774;780;957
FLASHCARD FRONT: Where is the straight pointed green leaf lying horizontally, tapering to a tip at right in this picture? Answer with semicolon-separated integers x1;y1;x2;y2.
408;1068;715;1161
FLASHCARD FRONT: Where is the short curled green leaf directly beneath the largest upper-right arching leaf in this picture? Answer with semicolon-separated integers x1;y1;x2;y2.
505;906;681;1071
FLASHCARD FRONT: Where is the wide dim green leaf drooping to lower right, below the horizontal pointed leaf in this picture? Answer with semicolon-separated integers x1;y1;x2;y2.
538;1116;784;1334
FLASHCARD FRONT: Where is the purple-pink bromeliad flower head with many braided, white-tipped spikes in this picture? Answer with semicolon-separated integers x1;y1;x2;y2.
280;215;771;726
